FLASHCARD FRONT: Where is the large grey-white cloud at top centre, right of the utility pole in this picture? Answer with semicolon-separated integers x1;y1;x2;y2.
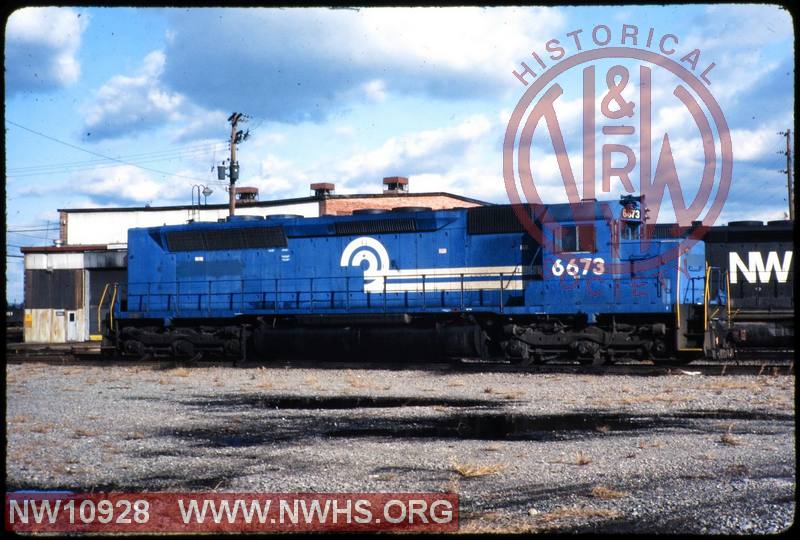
159;7;563;123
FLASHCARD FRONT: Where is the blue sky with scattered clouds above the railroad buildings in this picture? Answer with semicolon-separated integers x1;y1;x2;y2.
5;5;794;301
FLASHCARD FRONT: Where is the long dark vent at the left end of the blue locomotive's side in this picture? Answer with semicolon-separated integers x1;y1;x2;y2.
167;227;288;251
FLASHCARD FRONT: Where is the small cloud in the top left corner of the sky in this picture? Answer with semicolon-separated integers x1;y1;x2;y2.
5;7;88;93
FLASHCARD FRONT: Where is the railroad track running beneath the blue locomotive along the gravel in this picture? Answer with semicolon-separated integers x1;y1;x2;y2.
6;347;794;376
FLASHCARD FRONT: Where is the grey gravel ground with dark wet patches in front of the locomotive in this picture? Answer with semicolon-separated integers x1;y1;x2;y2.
6;364;795;534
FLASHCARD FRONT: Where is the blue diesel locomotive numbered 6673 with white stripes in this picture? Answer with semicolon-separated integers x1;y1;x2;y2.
110;196;730;364
